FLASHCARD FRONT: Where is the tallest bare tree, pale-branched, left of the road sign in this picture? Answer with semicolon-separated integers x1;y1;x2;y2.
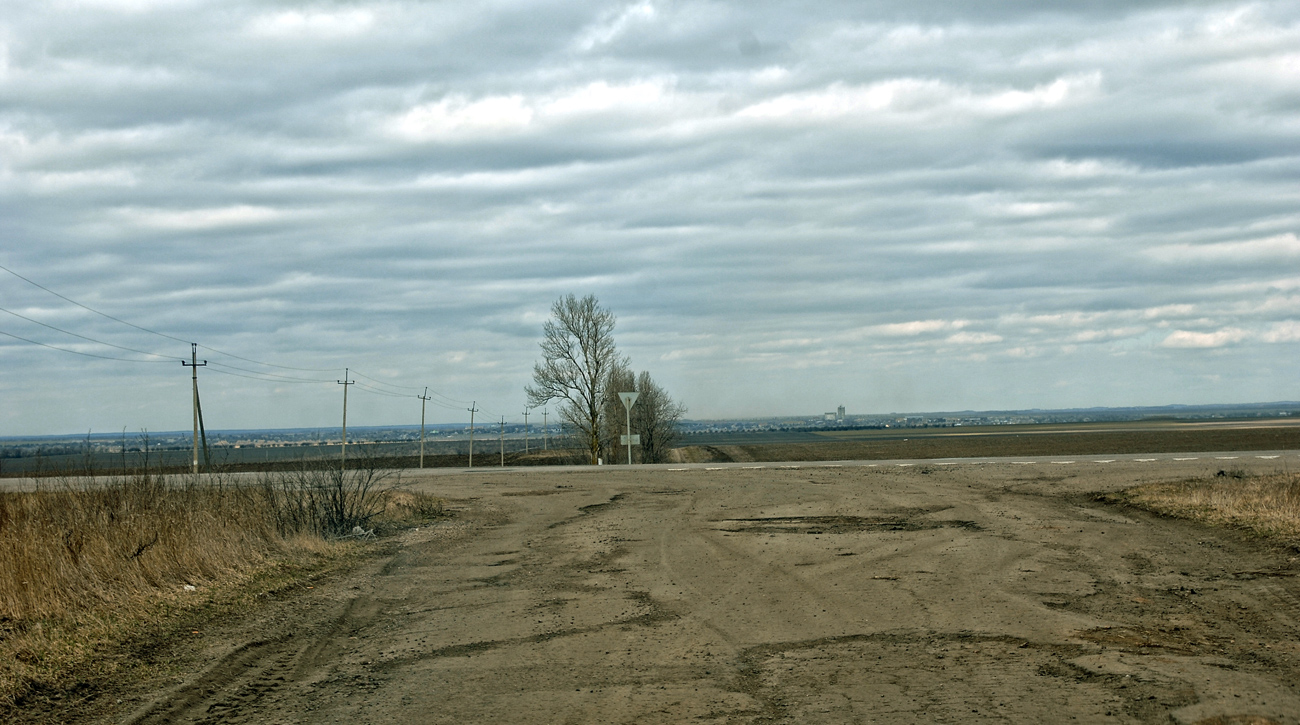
524;295;625;464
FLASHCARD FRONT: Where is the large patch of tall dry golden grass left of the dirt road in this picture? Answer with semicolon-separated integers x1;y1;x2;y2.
0;470;441;712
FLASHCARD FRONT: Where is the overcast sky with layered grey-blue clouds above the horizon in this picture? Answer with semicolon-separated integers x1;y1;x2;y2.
0;0;1300;435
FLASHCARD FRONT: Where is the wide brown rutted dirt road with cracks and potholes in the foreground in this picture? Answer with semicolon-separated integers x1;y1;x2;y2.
122;455;1300;724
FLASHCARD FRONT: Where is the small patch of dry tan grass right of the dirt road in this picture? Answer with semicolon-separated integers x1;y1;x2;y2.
1112;472;1300;548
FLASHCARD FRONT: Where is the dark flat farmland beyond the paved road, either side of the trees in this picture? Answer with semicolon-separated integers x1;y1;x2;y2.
0;418;1300;477
